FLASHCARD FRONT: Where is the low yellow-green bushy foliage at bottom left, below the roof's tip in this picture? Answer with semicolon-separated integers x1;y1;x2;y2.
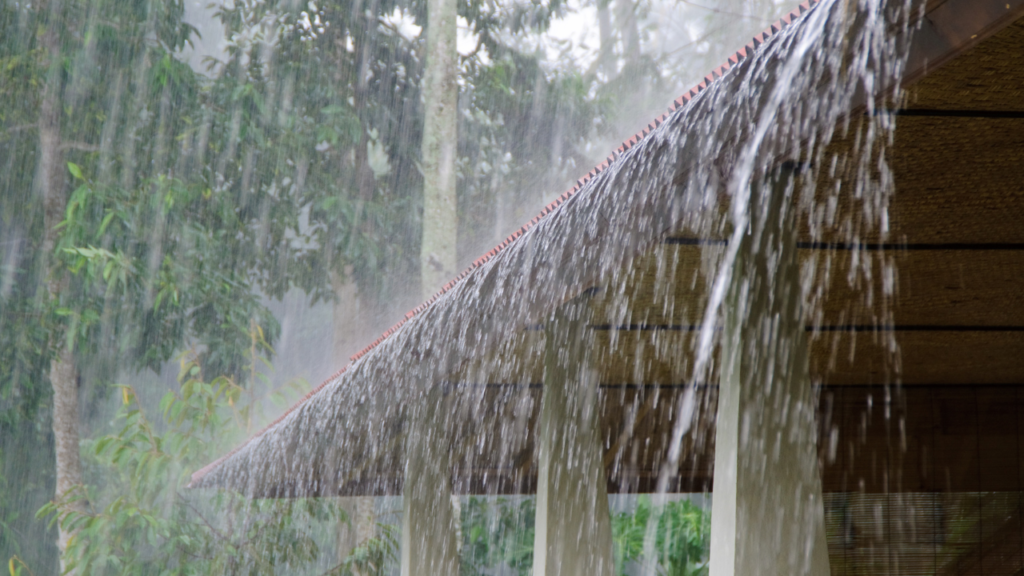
39;350;396;575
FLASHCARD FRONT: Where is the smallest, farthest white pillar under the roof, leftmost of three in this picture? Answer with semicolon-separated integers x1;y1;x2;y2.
401;392;460;576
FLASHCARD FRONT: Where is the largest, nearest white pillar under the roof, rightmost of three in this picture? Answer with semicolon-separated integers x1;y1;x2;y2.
710;169;829;576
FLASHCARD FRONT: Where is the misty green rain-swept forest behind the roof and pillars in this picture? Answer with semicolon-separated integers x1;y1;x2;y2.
0;0;790;574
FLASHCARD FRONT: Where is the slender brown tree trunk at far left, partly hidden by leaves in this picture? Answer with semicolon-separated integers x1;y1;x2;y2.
36;0;83;573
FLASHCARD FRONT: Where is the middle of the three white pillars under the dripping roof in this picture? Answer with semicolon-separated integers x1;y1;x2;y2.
534;296;614;576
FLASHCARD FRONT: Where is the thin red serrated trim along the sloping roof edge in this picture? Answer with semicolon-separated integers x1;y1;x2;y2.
189;0;821;486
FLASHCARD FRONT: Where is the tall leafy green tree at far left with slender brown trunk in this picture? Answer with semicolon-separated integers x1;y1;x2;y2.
0;0;316;568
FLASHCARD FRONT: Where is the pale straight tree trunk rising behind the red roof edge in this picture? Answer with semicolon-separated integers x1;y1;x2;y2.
420;0;459;298
